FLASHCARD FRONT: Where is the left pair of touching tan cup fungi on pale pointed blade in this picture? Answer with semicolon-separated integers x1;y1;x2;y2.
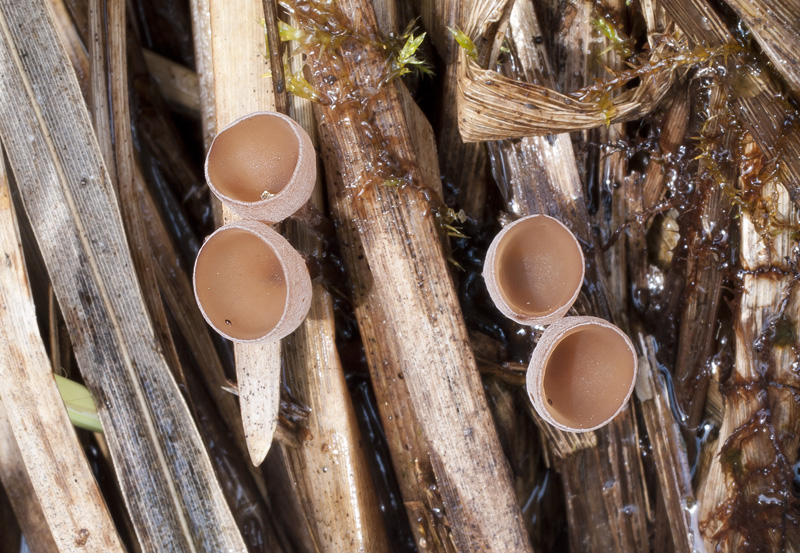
194;112;317;342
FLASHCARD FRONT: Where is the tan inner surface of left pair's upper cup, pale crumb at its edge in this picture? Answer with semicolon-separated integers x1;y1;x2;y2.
208;114;300;202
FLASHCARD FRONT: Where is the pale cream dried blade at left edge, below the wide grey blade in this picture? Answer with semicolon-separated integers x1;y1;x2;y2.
0;154;124;552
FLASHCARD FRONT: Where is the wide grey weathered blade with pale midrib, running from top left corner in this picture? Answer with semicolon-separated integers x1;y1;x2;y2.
0;2;244;551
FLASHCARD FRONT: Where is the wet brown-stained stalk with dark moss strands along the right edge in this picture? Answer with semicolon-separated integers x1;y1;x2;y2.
698;137;800;552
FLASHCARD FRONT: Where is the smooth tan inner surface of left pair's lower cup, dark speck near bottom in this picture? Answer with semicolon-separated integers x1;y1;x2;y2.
195;228;288;340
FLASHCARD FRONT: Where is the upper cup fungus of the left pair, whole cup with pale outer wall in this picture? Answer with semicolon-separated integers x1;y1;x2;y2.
205;112;317;223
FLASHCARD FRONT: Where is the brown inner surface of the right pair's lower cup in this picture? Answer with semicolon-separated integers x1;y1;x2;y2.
542;325;636;429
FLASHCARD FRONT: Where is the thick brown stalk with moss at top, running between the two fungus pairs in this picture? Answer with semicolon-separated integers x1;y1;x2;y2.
294;1;530;551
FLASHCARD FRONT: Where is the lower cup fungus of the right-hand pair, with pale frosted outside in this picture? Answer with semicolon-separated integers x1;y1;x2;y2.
527;317;638;432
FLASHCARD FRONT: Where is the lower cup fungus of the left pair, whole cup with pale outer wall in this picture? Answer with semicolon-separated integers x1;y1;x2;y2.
194;221;311;342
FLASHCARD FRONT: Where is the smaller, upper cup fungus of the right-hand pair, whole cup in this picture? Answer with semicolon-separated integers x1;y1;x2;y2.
483;211;584;325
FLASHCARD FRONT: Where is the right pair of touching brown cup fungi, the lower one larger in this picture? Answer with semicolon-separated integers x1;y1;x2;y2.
483;215;638;432
